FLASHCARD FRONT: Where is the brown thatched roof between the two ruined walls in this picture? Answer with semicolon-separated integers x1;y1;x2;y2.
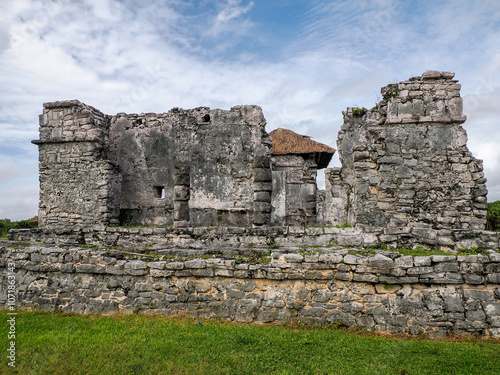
269;128;335;169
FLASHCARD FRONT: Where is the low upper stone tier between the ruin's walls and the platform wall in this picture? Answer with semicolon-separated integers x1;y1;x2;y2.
9;226;500;253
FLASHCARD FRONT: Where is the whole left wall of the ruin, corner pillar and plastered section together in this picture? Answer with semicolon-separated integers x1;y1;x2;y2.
34;101;272;228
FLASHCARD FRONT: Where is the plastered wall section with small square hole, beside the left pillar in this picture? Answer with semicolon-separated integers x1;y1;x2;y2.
109;106;271;226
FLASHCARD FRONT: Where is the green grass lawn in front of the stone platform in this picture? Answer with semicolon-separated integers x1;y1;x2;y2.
0;311;500;375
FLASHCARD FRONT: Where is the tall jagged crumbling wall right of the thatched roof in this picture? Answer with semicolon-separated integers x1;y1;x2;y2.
326;71;487;229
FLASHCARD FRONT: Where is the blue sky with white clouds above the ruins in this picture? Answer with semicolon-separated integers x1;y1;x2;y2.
0;0;500;219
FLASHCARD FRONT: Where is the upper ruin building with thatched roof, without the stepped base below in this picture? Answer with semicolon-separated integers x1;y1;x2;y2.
33;71;487;230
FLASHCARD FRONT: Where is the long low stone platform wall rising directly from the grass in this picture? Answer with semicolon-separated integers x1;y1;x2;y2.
0;246;500;338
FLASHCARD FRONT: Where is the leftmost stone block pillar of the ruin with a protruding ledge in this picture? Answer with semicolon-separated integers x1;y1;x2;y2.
33;100;120;229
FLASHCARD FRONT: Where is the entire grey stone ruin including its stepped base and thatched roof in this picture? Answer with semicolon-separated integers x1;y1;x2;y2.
4;71;500;338
